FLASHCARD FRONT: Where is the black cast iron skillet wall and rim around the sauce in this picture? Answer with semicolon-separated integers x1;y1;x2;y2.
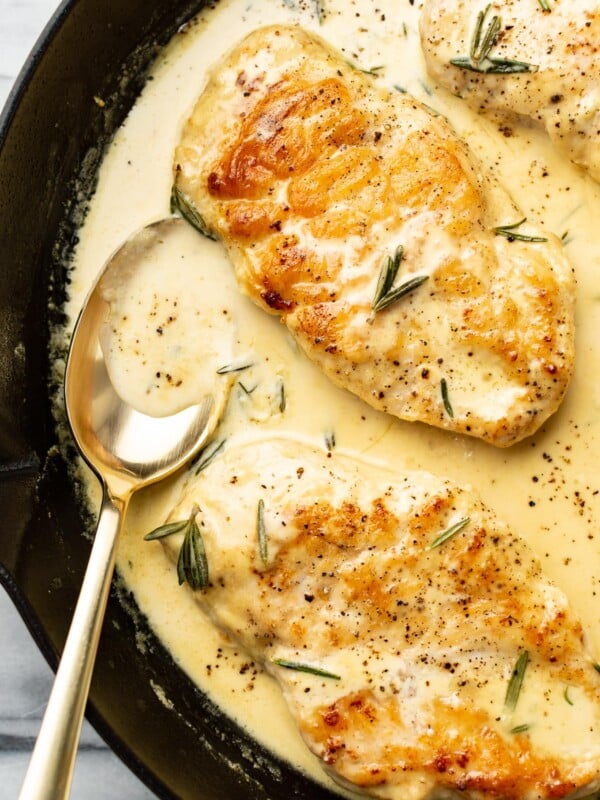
0;0;342;800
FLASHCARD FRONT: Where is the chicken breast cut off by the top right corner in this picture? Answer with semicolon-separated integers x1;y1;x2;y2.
421;0;600;180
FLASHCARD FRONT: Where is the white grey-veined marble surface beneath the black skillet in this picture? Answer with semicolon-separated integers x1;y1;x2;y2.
0;0;154;800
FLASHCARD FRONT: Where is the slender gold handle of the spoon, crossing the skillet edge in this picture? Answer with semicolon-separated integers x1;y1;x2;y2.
19;492;126;800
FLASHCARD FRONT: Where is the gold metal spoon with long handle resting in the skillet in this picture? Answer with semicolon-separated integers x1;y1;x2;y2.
20;218;227;800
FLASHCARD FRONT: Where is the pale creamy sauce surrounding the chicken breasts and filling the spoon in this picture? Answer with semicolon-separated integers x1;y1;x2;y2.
67;0;600;796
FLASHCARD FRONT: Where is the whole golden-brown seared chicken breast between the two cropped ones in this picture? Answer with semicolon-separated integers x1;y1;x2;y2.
174;26;573;446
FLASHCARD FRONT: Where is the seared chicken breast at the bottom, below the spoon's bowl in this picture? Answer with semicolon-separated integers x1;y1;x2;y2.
155;439;600;800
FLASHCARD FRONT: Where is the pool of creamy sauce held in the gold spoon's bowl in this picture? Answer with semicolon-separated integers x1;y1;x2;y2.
100;220;235;416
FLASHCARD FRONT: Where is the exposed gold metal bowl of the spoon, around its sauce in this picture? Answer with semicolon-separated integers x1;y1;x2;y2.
65;217;224;496
